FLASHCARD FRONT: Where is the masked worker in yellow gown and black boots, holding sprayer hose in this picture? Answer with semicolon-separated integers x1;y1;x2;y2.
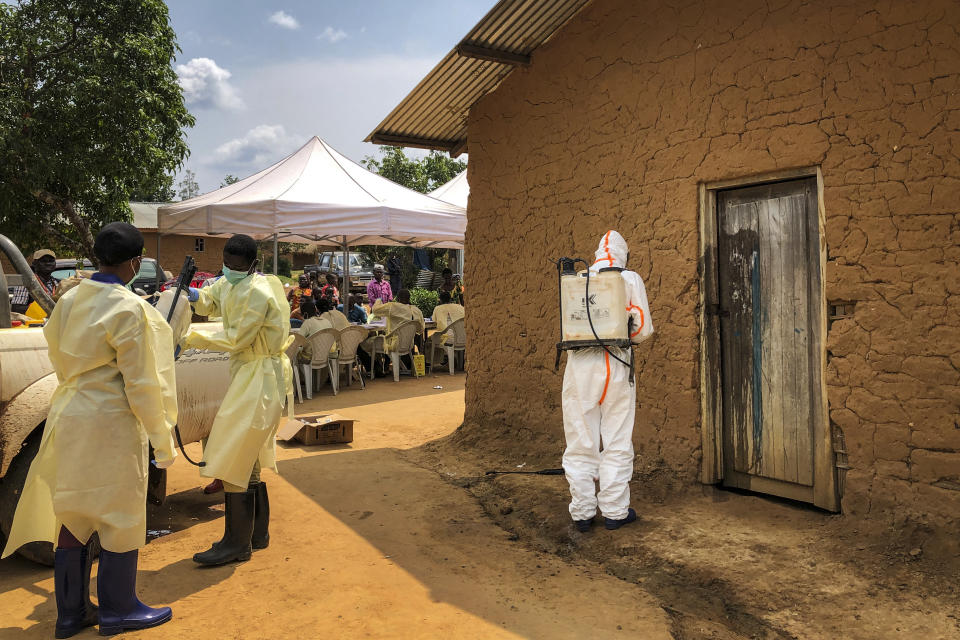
184;235;293;565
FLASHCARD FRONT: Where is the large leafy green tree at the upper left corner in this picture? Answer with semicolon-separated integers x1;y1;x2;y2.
0;0;194;260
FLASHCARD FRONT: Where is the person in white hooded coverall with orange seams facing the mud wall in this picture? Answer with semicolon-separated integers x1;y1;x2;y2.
562;231;653;532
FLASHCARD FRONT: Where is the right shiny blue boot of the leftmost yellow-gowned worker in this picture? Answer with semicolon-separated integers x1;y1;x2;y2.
97;549;173;636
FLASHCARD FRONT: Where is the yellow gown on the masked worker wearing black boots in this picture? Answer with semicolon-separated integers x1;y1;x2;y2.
184;274;293;487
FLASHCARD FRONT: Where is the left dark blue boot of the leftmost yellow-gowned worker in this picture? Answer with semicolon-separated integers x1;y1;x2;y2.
53;546;97;638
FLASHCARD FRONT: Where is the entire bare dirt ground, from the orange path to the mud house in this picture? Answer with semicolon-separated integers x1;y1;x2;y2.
0;375;960;640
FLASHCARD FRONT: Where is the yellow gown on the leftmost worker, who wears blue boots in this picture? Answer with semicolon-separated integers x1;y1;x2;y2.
3;280;177;557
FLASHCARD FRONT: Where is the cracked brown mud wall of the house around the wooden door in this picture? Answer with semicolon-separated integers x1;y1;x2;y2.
464;0;960;518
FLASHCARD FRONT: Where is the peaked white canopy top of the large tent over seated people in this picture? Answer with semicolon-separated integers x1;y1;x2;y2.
158;136;467;249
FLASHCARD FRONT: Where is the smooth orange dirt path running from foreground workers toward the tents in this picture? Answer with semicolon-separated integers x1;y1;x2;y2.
0;376;670;640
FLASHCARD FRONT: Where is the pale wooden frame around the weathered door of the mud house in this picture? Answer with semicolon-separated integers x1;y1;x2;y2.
698;166;840;511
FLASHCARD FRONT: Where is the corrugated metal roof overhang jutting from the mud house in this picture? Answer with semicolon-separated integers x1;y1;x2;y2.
366;0;590;155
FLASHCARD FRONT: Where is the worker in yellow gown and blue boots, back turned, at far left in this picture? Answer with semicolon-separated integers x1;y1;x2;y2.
3;222;177;638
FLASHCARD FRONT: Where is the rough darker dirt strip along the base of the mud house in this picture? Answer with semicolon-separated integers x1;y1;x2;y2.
413;429;960;640
